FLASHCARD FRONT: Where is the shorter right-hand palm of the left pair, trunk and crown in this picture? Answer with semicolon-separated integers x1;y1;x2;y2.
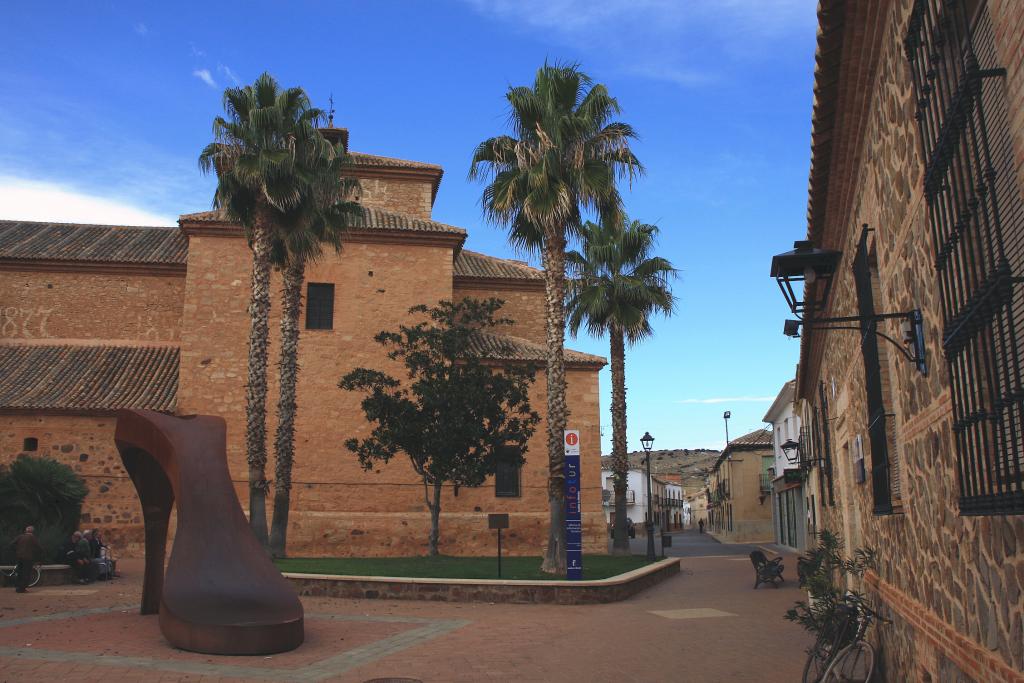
270;163;359;557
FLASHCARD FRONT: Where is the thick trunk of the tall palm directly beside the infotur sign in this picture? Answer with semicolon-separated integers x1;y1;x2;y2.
541;231;569;573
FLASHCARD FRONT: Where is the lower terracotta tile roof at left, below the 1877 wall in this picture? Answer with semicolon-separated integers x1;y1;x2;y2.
0;344;178;412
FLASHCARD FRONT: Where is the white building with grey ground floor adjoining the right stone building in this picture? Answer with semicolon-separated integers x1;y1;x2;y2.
764;380;814;550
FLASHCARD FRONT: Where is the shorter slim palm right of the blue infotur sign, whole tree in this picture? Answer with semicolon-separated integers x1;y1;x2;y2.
566;216;676;555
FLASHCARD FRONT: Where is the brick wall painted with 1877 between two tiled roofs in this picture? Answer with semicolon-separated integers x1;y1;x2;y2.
0;270;184;343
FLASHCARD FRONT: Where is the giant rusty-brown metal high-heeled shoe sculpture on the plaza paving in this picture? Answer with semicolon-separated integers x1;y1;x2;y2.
115;411;303;654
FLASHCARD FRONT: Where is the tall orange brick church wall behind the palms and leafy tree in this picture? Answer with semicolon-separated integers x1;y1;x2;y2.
178;236;604;555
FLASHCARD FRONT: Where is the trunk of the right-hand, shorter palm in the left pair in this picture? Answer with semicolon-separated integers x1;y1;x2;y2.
270;257;306;557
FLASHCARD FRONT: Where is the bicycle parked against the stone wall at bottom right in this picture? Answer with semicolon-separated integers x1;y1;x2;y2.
803;593;887;683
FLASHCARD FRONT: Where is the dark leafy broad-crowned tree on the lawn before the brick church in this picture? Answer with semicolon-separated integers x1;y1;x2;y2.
339;299;541;555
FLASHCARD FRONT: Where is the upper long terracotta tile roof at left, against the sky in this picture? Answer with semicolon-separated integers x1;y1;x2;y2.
0;220;188;265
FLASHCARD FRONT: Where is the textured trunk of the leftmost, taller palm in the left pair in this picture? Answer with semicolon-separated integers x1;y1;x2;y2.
246;208;270;547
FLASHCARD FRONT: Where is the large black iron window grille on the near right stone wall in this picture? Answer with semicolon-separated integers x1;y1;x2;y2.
904;0;1024;514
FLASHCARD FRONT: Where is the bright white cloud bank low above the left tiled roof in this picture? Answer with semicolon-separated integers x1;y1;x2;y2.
0;175;176;225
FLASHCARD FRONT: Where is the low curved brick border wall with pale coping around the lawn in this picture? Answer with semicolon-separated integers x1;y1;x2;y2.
285;558;679;605
